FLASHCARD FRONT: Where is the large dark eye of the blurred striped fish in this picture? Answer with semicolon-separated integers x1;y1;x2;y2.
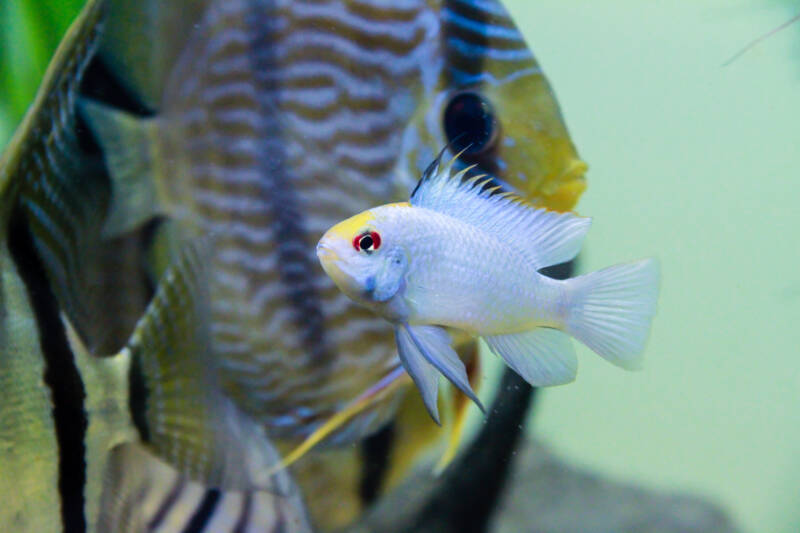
443;92;497;154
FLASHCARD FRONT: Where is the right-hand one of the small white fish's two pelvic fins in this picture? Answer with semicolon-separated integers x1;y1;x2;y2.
400;324;484;411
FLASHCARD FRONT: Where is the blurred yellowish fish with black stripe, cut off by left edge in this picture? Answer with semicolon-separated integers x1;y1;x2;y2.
0;2;308;531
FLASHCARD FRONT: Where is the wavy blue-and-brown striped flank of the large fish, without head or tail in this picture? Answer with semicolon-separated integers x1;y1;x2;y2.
142;0;444;436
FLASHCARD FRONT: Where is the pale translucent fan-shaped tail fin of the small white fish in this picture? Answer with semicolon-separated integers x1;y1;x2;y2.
564;259;659;370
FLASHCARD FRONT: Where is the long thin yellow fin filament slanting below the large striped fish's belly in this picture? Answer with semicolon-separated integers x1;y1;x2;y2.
270;367;409;472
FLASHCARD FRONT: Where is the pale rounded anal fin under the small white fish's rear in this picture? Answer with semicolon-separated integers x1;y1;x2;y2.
484;328;578;387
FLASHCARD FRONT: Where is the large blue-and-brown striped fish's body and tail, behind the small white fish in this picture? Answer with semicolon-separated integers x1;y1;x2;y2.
86;0;580;442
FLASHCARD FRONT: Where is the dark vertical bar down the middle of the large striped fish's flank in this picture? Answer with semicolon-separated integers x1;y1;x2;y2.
247;3;333;362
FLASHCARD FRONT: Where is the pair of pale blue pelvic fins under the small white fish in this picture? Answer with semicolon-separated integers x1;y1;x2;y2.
395;324;485;424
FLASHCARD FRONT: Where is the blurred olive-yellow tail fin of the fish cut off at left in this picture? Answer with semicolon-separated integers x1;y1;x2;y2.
125;239;278;490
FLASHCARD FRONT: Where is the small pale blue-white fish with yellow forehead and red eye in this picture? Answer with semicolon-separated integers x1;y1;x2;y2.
317;154;659;422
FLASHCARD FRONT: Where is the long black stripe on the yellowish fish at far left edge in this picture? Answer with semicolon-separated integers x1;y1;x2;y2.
8;210;89;533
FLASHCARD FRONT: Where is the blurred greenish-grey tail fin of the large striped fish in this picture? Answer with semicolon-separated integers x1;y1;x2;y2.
79;99;167;237
